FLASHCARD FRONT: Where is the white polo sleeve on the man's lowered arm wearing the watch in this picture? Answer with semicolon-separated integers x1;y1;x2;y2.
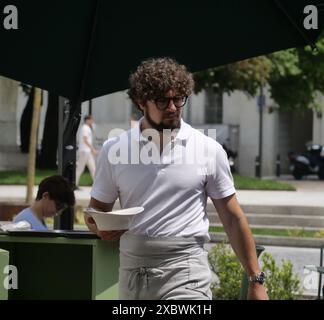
206;143;236;199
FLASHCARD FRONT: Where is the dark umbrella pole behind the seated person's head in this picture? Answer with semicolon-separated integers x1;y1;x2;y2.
54;97;81;230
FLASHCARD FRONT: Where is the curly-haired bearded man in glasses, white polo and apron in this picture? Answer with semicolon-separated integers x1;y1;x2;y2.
86;58;267;300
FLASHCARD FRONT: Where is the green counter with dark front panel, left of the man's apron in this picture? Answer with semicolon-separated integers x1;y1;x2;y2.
0;232;119;300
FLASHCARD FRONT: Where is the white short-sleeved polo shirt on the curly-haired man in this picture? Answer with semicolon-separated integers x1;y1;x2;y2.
91;120;235;240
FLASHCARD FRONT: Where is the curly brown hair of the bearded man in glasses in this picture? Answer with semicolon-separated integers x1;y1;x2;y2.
127;58;194;107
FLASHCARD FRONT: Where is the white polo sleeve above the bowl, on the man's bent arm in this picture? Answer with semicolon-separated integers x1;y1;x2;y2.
91;140;118;203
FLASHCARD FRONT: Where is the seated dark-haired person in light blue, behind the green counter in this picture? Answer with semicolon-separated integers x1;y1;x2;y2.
13;175;75;231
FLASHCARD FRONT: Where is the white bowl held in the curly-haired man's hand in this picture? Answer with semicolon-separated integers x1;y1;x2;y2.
84;207;144;231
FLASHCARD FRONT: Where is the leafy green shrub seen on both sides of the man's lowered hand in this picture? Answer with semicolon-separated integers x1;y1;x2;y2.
208;243;301;300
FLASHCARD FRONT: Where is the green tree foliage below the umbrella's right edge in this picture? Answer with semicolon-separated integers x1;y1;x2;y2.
195;36;324;111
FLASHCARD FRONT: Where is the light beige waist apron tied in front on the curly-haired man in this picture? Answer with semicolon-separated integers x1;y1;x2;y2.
119;232;212;300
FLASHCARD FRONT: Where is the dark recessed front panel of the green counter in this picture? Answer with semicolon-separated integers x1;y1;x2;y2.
1;243;92;300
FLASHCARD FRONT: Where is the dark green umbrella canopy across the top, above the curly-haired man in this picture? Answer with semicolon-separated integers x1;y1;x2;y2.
0;0;324;101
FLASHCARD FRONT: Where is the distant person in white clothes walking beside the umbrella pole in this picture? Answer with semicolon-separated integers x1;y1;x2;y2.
75;115;98;189
